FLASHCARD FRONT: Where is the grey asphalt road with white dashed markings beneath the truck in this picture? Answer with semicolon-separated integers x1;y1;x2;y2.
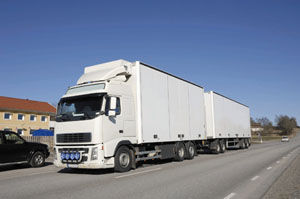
0;136;300;199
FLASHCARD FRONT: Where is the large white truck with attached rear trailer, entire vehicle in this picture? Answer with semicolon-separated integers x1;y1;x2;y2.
54;60;251;172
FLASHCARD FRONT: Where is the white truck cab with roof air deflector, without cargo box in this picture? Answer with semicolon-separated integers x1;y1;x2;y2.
54;60;136;169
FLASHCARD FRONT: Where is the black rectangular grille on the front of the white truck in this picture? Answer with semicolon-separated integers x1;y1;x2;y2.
56;133;92;143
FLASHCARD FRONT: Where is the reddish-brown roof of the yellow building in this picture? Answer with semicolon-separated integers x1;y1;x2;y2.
0;96;56;114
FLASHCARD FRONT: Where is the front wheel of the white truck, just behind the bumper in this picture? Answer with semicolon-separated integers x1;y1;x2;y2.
114;146;132;172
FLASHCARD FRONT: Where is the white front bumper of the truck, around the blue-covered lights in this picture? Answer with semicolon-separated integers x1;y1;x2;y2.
54;145;115;169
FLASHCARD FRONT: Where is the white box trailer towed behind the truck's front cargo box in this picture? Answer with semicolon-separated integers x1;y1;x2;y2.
204;91;251;152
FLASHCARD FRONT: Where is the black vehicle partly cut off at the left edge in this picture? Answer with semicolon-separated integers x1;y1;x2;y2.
0;131;50;167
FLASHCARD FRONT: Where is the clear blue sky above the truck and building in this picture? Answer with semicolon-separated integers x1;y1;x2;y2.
0;0;300;123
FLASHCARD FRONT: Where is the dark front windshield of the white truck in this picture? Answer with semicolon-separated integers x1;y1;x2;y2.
56;96;103;122
